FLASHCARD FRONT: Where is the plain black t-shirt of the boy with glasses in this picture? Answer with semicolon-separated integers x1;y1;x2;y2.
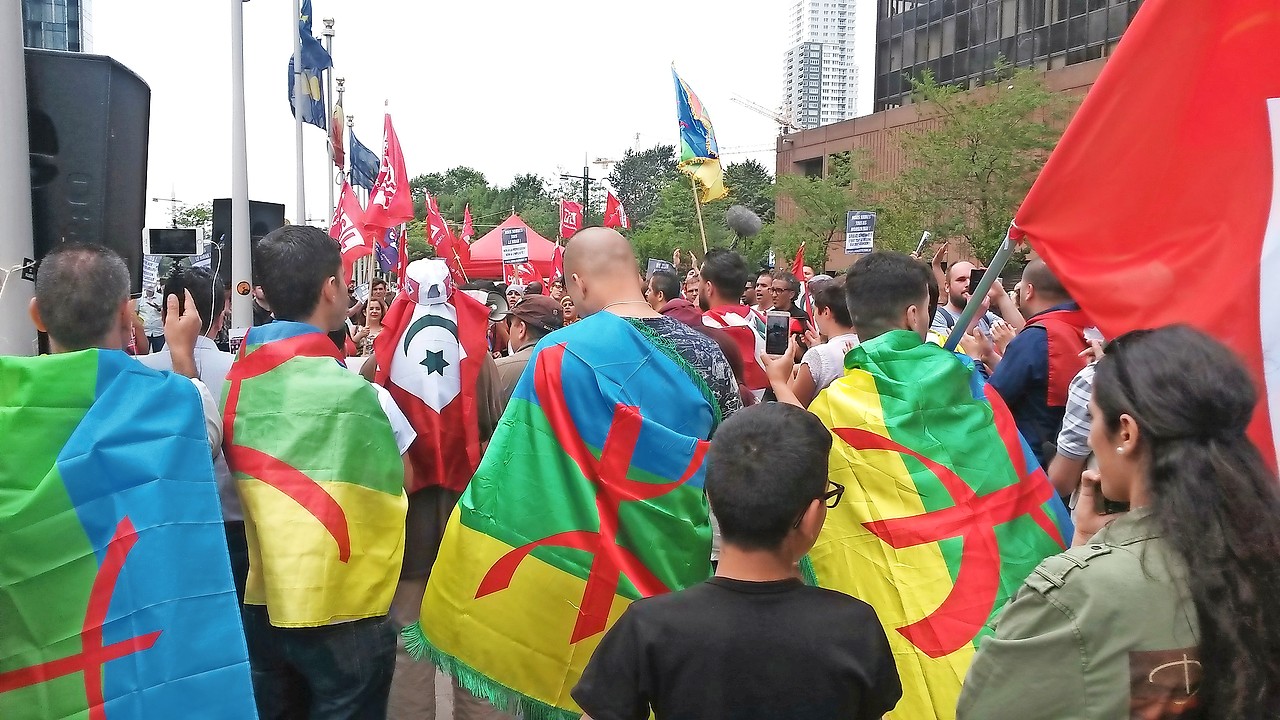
572;578;902;720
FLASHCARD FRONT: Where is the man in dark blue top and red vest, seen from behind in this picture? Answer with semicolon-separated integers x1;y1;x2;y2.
991;259;1093;469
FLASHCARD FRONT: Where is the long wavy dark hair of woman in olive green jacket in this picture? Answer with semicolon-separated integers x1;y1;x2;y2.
1093;325;1280;719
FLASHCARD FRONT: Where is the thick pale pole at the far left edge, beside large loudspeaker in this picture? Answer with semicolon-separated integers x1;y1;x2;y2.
0;3;36;355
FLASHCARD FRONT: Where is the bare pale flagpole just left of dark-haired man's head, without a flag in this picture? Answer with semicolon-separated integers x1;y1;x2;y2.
229;0;253;328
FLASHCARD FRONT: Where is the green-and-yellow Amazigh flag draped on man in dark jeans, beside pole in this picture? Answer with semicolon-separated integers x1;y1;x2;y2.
223;320;408;628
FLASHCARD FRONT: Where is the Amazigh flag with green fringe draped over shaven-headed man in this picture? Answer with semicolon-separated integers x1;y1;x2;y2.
404;313;719;720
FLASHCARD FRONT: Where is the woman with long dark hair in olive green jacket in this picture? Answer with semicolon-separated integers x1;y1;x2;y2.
957;325;1280;720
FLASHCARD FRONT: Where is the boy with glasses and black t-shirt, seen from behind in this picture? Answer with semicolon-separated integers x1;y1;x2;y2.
572;404;902;720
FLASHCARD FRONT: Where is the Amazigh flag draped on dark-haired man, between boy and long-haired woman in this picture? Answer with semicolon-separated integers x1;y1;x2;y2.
809;331;1071;720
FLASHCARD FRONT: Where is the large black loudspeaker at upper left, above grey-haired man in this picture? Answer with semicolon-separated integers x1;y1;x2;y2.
26;49;151;295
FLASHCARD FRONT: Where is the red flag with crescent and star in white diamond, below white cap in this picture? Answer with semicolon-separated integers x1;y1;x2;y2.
374;259;489;493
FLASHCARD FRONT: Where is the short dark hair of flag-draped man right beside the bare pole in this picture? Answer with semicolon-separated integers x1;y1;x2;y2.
253;225;342;322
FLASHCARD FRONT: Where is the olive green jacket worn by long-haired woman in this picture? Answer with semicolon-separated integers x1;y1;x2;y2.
956;509;1202;720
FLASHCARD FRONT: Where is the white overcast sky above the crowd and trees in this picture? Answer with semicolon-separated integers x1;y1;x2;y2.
92;0;790;227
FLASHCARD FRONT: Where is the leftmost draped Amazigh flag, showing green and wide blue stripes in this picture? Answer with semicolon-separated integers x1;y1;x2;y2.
0;350;256;720
